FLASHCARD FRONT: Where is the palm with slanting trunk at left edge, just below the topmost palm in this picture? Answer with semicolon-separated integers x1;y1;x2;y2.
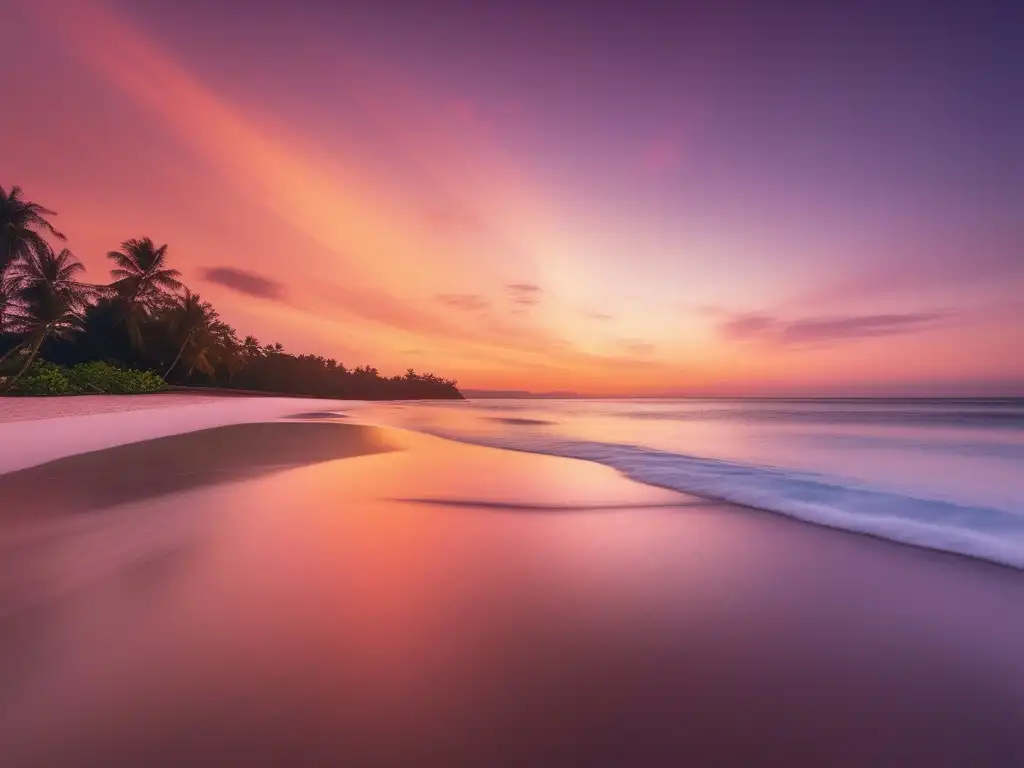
0;243;96;390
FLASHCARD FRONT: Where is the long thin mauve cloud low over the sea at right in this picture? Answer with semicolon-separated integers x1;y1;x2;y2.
718;311;949;346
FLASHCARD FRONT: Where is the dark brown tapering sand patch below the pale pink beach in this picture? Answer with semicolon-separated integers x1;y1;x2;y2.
0;422;395;519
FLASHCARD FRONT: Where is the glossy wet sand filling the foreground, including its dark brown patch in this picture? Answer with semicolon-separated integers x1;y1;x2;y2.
0;421;1024;767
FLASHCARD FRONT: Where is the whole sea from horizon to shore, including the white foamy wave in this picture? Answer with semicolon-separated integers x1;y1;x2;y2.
360;398;1024;567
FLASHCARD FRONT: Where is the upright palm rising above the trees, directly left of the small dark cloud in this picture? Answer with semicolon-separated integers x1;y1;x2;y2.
106;238;182;347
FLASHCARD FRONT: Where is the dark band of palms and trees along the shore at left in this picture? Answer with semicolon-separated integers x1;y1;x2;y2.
0;186;463;399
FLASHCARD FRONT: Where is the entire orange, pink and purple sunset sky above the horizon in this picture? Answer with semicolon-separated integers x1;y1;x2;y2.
0;0;1024;394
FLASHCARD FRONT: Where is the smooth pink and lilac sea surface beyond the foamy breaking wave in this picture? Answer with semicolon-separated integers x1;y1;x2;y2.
358;400;1024;518
